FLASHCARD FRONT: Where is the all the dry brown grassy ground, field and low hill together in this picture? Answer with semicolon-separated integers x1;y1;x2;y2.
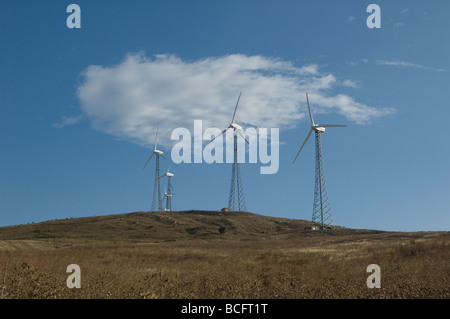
0;212;450;299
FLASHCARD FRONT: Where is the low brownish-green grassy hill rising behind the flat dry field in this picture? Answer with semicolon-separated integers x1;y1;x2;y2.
0;211;380;242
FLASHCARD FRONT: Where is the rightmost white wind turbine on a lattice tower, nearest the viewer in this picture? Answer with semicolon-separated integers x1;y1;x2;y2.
293;93;347;230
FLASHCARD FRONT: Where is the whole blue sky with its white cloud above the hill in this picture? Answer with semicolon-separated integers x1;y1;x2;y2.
0;0;450;231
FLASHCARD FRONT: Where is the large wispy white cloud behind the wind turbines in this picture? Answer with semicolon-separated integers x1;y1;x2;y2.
78;54;394;146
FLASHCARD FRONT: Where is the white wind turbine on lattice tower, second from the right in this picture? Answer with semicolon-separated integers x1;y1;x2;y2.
211;92;249;211
